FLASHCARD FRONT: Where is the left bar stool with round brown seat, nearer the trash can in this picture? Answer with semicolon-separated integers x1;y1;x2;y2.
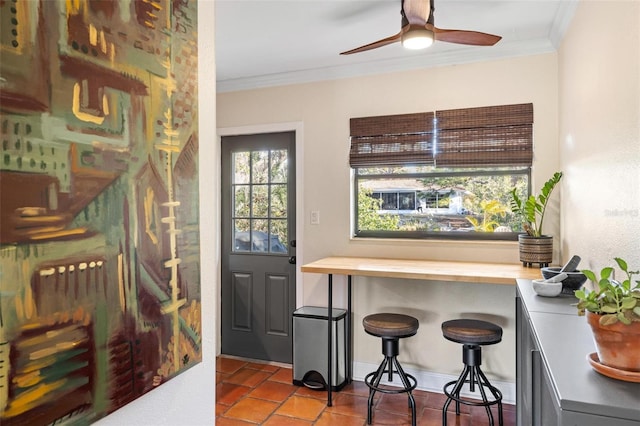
362;313;419;426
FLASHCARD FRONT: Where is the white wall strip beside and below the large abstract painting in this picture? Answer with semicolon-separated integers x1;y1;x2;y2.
95;1;220;426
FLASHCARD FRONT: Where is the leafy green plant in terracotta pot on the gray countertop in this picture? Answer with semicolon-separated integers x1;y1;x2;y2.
575;257;640;372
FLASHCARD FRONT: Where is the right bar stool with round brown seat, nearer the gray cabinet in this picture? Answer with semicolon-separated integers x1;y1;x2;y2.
442;319;503;426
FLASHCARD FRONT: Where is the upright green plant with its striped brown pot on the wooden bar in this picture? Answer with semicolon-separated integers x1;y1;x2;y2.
510;172;562;267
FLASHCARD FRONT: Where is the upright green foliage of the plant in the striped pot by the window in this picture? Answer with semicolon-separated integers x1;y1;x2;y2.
510;172;562;237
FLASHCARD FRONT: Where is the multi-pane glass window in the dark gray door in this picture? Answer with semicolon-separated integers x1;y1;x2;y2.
232;150;288;254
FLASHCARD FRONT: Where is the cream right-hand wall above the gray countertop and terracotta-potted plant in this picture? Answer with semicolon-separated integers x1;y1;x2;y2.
559;0;640;270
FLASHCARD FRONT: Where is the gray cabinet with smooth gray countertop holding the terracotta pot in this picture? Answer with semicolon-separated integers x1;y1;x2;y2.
516;280;640;426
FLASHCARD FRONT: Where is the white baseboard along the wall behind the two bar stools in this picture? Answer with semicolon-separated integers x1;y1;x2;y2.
353;362;516;404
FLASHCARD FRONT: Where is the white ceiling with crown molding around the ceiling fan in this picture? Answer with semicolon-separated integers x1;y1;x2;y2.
216;0;578;92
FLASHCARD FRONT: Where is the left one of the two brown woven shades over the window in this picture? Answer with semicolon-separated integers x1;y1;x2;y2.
349;112;434;167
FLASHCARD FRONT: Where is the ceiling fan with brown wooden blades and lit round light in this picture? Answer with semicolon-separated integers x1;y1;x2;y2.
340;0;502;55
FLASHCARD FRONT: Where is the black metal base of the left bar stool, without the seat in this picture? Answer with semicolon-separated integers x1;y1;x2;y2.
364;356;418;426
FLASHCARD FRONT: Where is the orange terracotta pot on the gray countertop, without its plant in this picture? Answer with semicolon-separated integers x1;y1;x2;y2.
587;312;640;371
